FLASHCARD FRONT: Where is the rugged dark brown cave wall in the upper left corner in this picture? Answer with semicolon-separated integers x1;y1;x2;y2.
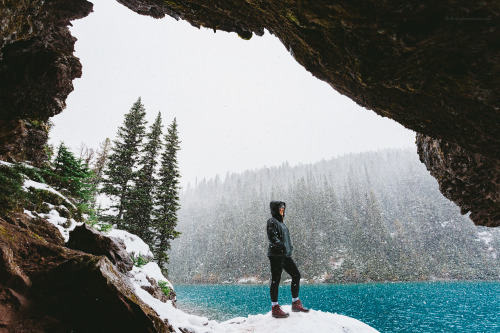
0;0;93;164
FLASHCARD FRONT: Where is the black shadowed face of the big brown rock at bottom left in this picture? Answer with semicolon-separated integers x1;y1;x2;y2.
34;254;170;332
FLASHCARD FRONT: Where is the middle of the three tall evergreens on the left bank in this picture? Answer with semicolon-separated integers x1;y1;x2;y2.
124;112;162;246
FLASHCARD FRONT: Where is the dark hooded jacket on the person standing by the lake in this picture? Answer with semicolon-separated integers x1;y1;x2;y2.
267;201;293;257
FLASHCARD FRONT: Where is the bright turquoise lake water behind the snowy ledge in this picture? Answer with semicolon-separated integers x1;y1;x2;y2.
174;282;500;333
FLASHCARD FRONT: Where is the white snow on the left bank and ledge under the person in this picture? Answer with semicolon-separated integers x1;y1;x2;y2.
17;169;378;333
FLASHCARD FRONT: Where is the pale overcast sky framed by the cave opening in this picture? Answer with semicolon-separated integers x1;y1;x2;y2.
50;0;416;186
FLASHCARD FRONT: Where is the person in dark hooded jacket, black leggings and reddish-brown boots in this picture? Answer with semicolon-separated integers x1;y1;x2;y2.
267;201;309;318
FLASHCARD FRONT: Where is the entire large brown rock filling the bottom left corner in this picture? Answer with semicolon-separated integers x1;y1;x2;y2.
0;216;173;332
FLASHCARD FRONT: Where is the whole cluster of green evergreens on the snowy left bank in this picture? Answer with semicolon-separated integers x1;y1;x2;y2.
47;98;180;274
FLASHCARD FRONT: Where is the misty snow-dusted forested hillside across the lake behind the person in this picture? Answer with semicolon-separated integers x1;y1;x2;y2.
168;150;500;283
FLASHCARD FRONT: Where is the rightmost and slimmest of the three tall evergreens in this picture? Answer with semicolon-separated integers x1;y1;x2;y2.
153;118;180;274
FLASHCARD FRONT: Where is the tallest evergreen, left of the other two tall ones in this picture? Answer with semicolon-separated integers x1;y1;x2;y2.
102;97;146;229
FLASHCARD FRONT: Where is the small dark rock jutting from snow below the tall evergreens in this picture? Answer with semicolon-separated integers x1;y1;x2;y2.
66;224;134;273
